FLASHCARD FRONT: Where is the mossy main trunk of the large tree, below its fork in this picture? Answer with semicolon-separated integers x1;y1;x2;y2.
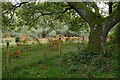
87;25;108;56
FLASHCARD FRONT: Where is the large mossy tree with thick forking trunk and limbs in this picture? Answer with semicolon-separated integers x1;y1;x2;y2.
68;2;120;55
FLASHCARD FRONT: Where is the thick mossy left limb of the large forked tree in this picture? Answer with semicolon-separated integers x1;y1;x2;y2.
68;2;96;24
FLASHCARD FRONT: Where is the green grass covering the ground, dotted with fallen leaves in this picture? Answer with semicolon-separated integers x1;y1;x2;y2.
2;43;118;78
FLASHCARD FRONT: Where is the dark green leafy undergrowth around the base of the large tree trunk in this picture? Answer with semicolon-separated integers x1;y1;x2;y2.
61;43;118;78
